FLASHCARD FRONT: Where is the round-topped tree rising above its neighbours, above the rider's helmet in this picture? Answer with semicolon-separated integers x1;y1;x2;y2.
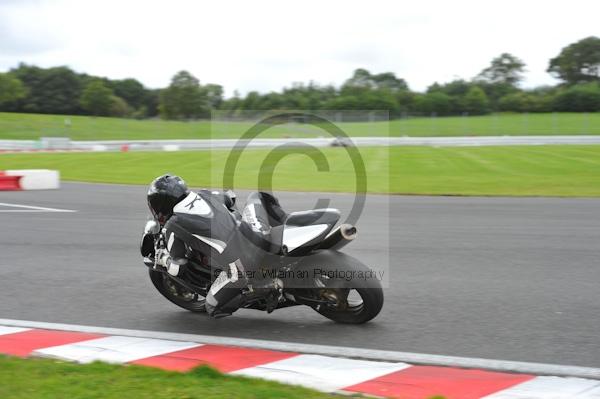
159;71;209;119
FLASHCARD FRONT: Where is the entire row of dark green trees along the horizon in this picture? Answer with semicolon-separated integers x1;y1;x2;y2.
0;37;600;120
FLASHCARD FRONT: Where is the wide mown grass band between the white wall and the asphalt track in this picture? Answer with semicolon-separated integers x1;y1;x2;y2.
0;145;600;197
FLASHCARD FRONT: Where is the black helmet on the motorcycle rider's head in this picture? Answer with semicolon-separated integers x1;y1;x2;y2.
148;174;190;224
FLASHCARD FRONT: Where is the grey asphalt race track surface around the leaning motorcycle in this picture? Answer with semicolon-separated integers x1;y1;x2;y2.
0;183;600;367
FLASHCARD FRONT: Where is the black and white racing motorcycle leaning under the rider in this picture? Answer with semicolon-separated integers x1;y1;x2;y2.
140;193;383;324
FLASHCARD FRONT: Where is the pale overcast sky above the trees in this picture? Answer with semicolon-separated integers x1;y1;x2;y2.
0;0;600;96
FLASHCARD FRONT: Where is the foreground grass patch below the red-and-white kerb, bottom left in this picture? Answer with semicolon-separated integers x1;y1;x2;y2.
0;356;332;399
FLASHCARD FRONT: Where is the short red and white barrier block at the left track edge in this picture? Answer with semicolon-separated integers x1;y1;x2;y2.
0;169;60;191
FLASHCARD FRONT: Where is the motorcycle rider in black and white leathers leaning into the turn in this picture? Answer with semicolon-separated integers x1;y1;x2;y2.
148;174;286;317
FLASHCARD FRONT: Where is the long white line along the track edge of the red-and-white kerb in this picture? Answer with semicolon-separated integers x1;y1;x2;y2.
0;319;600;380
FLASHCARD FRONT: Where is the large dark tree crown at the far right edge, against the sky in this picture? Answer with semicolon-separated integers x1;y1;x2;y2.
547;36;600;84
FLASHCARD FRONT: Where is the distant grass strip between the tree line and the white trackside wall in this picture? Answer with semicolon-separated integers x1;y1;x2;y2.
0;113;600;140
